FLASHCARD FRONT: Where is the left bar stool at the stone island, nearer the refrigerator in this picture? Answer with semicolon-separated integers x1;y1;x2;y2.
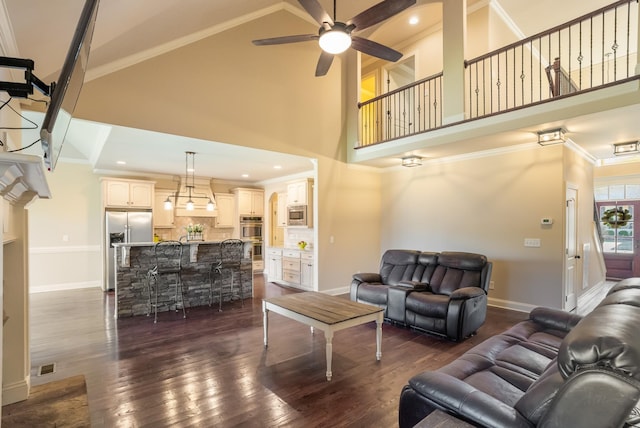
147;241;187;323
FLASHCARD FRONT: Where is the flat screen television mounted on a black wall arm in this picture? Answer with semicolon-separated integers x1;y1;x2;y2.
40;0;100;171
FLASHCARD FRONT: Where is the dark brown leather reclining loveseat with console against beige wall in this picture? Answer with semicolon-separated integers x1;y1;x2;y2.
350;249;492;340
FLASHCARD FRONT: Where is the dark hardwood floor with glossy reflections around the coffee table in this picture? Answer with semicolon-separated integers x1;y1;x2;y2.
25;275;526;427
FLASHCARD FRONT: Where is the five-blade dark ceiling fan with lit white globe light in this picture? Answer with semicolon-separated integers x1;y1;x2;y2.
253;0;416;77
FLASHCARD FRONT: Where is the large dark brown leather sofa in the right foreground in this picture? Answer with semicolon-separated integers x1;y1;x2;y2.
399;278;640;428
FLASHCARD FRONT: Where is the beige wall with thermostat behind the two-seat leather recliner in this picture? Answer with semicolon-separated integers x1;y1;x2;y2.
382;145;564;310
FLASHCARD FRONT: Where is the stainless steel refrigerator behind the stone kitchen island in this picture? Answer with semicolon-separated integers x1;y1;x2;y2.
104;211;153;290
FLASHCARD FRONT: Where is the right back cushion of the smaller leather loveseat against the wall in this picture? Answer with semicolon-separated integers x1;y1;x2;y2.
429;251;487;295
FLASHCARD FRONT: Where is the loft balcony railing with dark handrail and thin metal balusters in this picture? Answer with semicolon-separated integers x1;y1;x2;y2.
359;0;640;147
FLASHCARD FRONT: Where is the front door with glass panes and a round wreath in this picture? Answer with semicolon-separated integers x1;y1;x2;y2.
597;201;640;279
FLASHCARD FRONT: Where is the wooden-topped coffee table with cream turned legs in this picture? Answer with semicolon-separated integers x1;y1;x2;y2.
262;291;384;381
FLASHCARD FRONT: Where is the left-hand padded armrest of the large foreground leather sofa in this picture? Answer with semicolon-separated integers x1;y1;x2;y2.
409;371;531;427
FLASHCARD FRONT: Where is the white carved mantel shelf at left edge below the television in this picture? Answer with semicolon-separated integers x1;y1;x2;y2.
0;152;51;202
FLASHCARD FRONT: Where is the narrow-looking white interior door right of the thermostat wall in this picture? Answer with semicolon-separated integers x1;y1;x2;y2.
563;186;580;311
